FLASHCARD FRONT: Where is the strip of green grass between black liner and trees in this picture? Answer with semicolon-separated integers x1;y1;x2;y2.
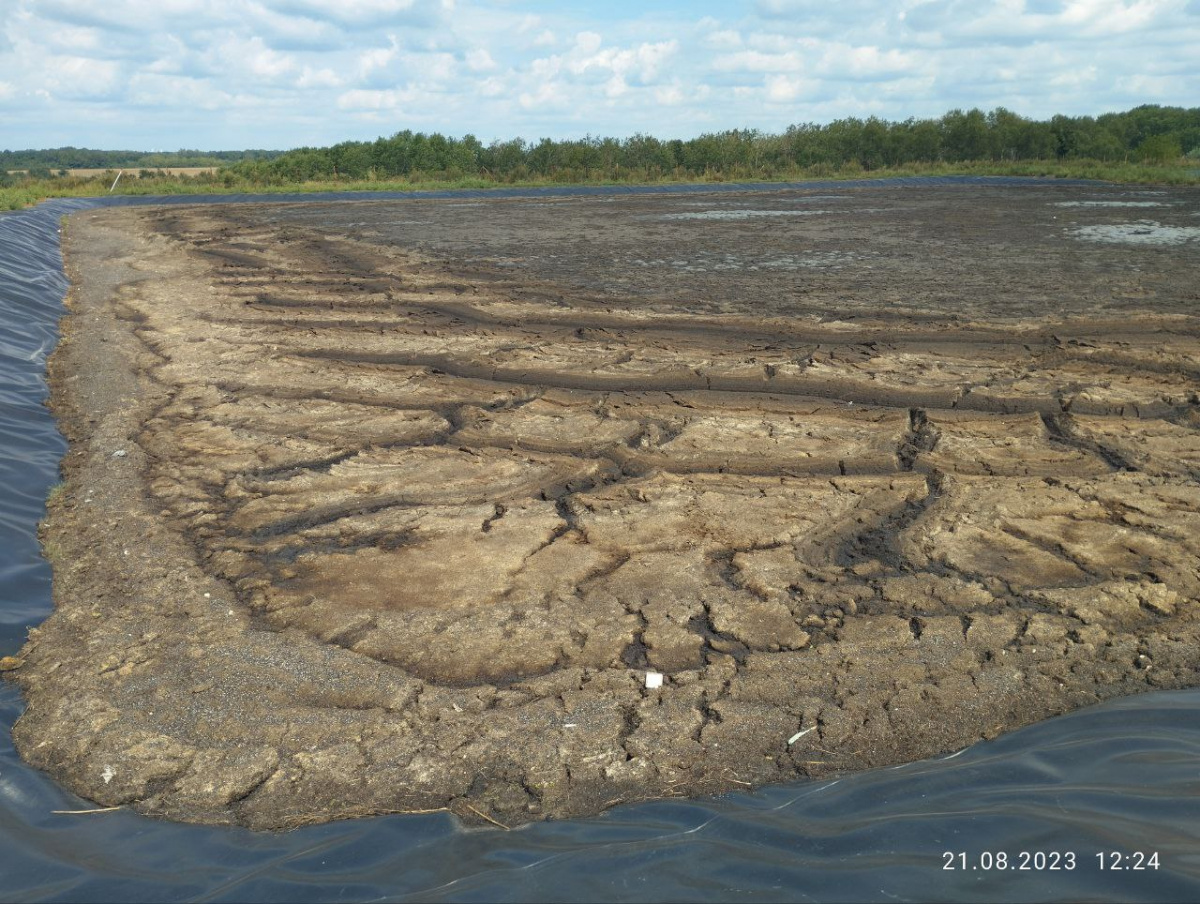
0;160;1200;210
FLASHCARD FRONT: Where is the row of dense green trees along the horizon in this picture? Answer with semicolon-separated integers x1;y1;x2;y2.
229;106;1200;184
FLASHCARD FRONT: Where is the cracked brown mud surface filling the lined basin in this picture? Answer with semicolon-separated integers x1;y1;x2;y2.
11;181;1200;827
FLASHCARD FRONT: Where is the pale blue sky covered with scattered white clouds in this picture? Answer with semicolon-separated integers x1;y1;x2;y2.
0;0;1200;150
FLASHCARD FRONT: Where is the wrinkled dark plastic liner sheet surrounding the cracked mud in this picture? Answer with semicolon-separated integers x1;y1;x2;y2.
0;179;1200;902
